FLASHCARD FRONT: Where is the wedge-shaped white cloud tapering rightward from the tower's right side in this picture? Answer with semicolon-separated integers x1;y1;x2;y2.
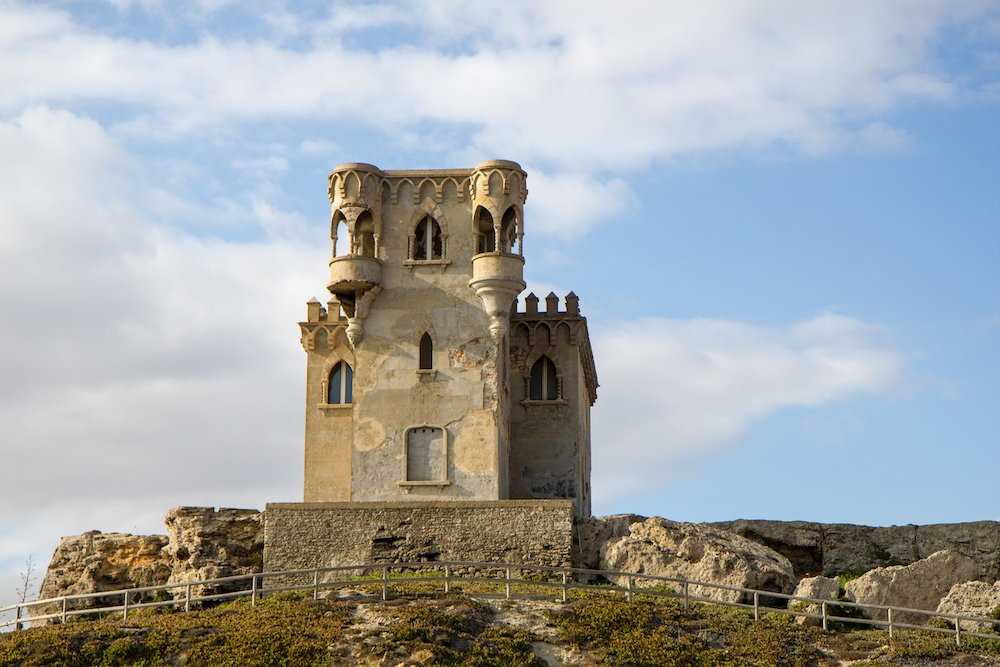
592;313;902;502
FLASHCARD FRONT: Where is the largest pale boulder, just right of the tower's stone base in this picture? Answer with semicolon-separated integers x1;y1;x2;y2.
601;517;795;606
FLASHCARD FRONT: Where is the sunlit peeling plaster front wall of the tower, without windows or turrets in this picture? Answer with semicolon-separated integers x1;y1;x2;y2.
305;183;507;501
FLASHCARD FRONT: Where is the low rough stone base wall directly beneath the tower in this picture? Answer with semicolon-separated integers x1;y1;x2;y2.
264;500;573;570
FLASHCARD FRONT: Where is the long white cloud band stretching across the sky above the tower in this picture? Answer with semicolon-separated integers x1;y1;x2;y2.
0;1;987;164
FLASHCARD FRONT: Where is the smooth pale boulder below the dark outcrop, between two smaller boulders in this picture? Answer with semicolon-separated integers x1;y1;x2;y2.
846;551;978;625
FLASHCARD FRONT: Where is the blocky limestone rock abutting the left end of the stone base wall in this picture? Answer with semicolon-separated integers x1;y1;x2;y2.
164;507;264;597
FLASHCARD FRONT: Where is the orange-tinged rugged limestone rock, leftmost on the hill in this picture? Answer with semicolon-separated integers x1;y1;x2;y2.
34;530;170;615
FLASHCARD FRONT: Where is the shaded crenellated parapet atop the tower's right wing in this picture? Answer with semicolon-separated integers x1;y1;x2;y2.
510;292;599;405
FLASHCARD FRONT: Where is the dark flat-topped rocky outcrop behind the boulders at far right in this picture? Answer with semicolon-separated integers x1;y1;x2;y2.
710;519;1000;582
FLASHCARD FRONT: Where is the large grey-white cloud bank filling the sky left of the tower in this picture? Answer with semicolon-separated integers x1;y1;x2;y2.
0;108;326;604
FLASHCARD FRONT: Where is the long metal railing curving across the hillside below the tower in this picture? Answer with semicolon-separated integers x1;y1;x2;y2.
0;561;1000;646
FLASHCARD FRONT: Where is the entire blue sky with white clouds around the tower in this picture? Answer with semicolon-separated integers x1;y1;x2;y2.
0;0;1000;602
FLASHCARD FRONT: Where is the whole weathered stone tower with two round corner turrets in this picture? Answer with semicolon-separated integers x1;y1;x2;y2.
300;160;597;516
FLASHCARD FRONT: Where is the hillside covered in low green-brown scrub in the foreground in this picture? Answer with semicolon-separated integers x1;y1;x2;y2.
0;591;1000;666
